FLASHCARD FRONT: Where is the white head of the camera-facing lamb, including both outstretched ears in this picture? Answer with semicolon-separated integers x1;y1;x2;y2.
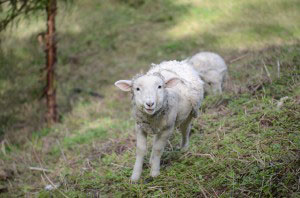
115;75;181;115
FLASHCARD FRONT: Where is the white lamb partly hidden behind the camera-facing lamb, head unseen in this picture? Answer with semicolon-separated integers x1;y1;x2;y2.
184;52;227;94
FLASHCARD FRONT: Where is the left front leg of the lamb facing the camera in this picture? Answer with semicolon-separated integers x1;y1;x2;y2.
131;125;147;182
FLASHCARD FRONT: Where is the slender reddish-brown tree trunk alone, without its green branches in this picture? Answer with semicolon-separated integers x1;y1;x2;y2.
45;0;57;124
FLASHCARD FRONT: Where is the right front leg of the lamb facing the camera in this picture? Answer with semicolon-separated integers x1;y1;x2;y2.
150;127;173;177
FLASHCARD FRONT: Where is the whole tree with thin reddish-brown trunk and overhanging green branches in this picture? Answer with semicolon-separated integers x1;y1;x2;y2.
0;0;72;125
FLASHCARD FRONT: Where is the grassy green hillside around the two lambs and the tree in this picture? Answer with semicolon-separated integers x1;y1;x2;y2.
0;0;300;197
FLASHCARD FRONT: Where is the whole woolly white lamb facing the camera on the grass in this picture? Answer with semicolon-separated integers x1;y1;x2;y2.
115;61;204;182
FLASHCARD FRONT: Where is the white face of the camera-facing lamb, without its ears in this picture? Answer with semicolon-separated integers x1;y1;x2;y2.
132;75;166;115
